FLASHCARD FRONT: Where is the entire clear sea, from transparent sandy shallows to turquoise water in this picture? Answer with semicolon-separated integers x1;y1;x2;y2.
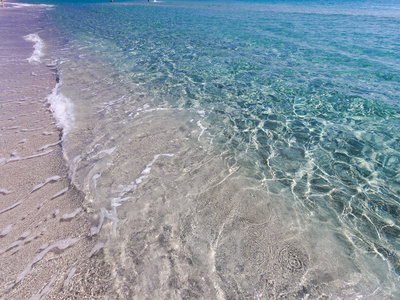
21;0;400;299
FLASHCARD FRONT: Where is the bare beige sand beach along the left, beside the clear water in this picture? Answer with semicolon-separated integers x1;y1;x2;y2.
0;3;113;299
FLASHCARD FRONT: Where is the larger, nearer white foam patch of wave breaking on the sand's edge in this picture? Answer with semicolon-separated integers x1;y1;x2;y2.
47;81;75;139
